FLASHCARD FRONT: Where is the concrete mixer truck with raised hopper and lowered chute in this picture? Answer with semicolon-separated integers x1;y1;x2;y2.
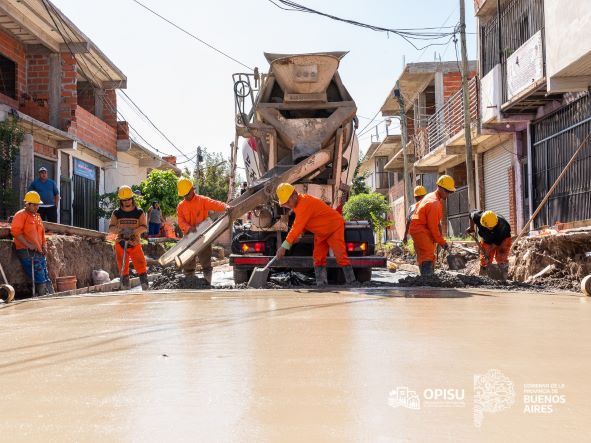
161;52;386;284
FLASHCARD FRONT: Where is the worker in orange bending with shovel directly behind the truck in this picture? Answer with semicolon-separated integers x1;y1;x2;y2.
276;183;356;287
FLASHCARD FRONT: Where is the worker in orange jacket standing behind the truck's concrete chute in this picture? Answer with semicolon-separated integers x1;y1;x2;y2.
176;178;228;284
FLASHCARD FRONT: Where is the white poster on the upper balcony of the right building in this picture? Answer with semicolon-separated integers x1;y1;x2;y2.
507;31;544;100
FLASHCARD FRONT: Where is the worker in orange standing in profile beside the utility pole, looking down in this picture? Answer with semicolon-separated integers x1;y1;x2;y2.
409;175;456;275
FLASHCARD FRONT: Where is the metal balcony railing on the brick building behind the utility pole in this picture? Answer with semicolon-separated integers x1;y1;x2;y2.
426;77;480;156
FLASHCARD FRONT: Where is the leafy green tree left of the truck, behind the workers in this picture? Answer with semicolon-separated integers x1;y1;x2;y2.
139;169;180;217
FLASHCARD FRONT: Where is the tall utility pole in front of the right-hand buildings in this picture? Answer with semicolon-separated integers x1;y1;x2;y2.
460;0;476;210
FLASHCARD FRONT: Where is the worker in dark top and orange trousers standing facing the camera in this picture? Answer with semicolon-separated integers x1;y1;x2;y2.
109;186;149;291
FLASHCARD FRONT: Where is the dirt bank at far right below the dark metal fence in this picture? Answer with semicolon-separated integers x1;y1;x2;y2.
510;230;591;292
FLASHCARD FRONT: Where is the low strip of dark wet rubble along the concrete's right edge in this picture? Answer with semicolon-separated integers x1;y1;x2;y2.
396;271;541;291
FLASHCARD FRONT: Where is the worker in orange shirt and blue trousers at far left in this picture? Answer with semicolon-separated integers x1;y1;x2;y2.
10;191;53;295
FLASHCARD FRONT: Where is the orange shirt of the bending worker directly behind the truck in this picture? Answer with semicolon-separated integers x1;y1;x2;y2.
285;194;345;245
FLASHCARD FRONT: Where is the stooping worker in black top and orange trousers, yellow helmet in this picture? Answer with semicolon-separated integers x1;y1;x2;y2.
466;211;513;278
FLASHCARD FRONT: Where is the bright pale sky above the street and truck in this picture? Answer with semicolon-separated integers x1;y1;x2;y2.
53;0;476;169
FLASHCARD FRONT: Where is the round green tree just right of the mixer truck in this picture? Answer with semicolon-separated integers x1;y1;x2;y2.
343;192;392;244
